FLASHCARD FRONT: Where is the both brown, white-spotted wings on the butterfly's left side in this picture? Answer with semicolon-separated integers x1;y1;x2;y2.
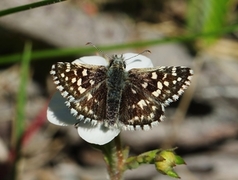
50;62;107;121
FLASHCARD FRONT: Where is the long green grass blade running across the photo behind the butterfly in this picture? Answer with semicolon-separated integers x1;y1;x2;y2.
0;24;238;64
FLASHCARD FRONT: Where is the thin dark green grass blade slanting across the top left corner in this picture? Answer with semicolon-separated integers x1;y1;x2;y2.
0;0;66;17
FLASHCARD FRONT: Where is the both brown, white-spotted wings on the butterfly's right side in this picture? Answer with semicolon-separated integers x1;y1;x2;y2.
120;67;192;129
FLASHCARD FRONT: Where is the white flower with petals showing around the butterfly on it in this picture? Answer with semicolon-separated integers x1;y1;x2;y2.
47;53;153;145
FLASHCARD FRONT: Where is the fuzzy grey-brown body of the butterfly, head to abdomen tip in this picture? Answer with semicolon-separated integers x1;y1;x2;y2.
106;55;127;126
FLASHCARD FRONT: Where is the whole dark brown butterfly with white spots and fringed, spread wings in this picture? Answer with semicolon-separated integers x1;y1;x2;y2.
50;54;193;130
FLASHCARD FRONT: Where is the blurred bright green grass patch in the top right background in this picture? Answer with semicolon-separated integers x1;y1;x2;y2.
187;0;231;44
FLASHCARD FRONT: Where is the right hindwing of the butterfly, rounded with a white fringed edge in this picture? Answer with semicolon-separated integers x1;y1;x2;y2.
120;83;164;130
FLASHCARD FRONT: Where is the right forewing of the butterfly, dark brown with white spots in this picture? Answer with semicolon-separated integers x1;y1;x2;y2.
129;66;193;106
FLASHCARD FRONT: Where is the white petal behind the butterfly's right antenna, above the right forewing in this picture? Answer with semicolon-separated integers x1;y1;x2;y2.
123;53;154;71
